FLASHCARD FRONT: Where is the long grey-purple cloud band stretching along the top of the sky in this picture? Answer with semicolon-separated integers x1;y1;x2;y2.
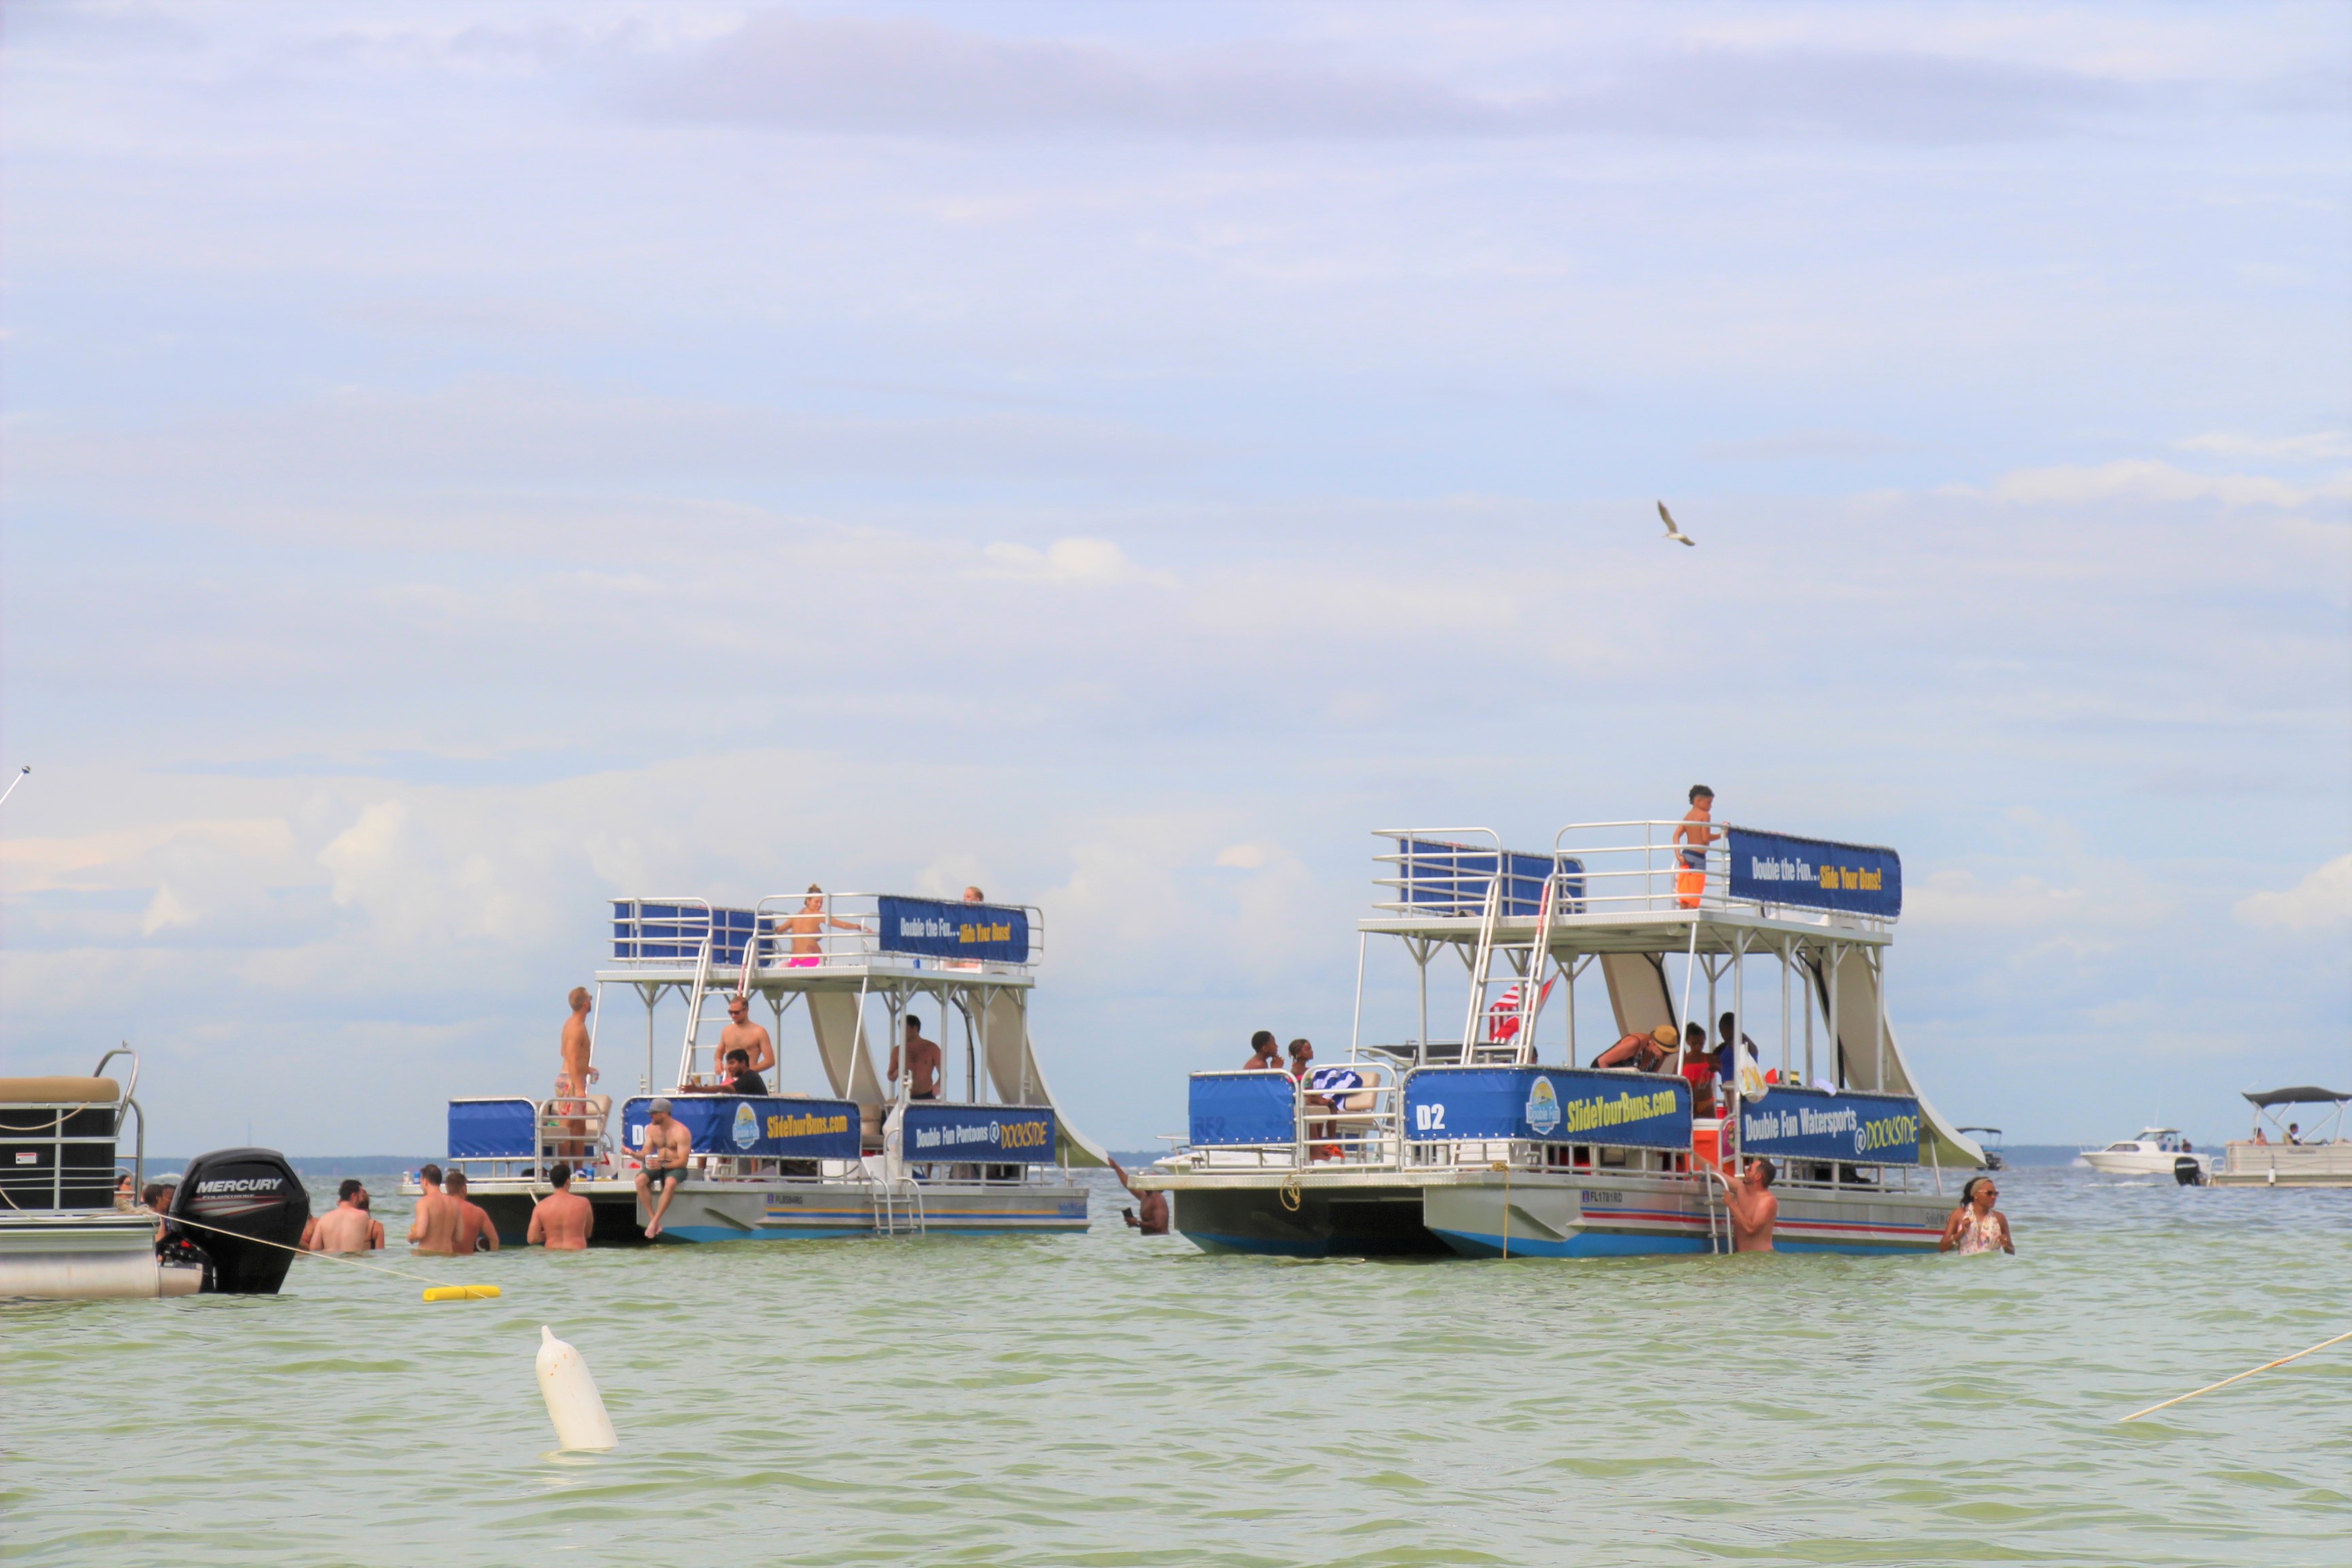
614;10;2161;144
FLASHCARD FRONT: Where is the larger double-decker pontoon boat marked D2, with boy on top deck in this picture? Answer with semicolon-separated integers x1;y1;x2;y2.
1136;823;1985;1258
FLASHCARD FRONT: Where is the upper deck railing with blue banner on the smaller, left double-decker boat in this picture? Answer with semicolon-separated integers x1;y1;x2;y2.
612;894;1044;978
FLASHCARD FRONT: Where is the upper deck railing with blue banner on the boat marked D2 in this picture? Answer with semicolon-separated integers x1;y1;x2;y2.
1371;821;1903;928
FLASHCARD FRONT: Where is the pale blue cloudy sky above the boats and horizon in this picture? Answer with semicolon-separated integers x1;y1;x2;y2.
0;0;2352;1154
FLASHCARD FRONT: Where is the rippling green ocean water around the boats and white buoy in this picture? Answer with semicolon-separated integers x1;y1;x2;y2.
0;1171;2352;1568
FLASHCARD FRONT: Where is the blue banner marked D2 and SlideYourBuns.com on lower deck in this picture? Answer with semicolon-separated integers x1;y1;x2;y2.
1404;1067;1691;1149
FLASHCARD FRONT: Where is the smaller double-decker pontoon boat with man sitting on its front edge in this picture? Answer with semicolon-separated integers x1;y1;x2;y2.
427;894;1105;1243
